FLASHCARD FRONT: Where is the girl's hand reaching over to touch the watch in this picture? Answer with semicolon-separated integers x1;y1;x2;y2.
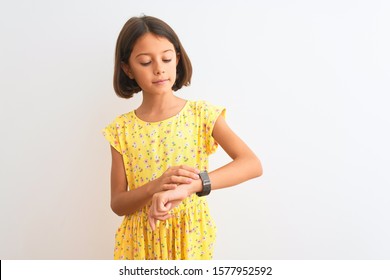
153;165;200;193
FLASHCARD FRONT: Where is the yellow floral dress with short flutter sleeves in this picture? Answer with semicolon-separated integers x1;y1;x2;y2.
103;101;225;260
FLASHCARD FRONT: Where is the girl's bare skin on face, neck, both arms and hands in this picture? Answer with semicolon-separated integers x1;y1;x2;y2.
111;33;262;229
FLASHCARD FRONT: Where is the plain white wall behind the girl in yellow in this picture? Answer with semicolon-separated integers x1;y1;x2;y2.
0;0;390;259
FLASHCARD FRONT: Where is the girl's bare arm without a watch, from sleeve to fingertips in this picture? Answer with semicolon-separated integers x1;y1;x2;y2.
111;146;199;216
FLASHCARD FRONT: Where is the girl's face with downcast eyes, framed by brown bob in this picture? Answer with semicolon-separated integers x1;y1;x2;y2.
123;33;179;95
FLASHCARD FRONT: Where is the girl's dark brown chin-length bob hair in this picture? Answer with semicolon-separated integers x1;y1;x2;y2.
114;16;192;98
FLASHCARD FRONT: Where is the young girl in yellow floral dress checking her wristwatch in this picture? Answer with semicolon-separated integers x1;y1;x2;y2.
103;16;262;260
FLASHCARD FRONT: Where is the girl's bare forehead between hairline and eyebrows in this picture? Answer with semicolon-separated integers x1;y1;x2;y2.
131;33;175;56
